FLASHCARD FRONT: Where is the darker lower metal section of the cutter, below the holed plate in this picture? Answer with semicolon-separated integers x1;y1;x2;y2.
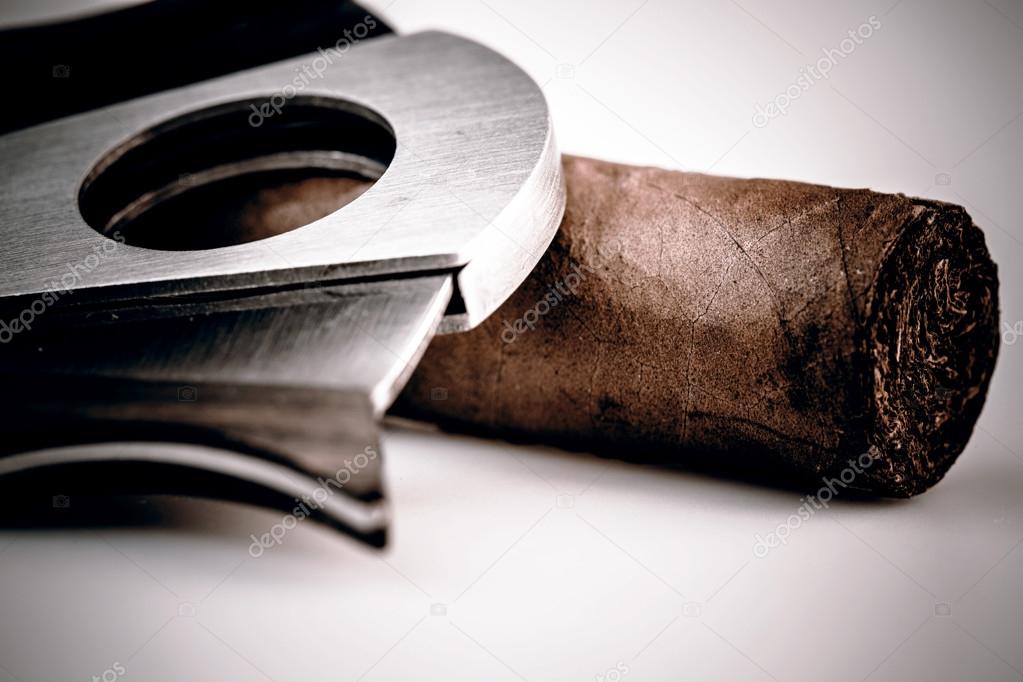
0;274;452;544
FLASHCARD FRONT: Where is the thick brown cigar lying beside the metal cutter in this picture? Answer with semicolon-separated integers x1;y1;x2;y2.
396;157;998;497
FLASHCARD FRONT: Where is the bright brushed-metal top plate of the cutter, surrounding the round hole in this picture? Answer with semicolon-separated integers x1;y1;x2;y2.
0;27;564;330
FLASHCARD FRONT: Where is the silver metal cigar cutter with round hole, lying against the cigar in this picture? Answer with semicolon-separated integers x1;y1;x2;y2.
0;33;565;545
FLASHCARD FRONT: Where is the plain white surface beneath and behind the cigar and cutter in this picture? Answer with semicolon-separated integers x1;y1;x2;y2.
0;0;1023;682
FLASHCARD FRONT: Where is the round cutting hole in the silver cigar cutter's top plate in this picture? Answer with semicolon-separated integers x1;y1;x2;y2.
79;98;395;251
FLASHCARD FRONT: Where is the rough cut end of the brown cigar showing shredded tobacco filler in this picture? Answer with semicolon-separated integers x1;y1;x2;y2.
865;199;998;497
